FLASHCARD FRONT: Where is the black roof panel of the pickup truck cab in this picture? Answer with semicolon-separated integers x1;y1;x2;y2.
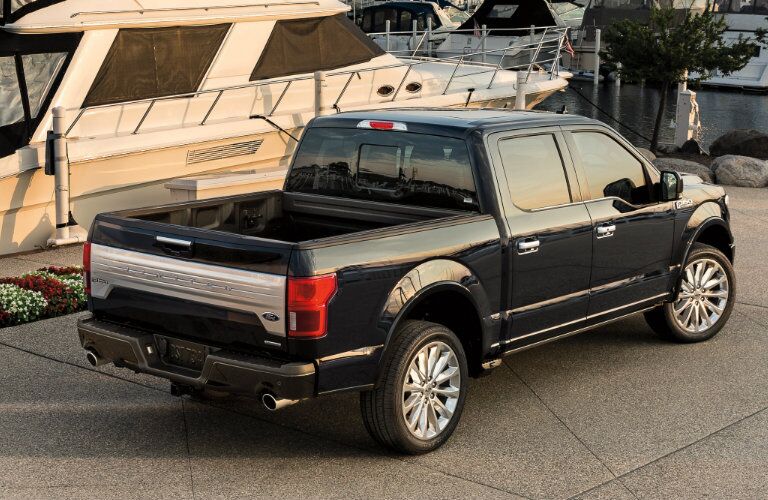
312;108;605;136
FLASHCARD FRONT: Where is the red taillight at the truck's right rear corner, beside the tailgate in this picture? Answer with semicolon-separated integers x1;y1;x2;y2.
288;274;336;337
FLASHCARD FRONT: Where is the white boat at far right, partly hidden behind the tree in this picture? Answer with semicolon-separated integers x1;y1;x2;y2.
701;0;768;91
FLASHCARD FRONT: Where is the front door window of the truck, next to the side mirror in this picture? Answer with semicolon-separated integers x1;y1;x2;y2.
573;132;651;205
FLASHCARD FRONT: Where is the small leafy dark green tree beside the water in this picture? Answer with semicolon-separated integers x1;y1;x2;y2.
600;7;765;151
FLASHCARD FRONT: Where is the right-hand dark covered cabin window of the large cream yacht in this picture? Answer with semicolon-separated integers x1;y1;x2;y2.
251;14;385;81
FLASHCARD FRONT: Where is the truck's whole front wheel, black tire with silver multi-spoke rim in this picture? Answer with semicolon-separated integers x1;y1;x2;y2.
645;243;736;342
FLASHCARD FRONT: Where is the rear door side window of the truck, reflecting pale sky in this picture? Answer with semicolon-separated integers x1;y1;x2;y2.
499;134;571;210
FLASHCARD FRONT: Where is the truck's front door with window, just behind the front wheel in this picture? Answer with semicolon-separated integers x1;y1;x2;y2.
564;127;674;322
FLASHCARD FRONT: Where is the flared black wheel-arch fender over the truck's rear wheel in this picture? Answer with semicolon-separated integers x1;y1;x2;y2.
379;259;494;364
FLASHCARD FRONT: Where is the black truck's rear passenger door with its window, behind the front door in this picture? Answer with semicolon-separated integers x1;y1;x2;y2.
491;128;592;350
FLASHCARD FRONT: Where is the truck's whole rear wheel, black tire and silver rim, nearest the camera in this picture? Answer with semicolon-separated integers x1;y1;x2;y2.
360;321;468;454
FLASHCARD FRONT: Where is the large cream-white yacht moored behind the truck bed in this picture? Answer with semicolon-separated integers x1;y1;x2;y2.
0;0;567;254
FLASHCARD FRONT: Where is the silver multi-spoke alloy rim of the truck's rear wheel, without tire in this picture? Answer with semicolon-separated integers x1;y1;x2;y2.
402;341;461;439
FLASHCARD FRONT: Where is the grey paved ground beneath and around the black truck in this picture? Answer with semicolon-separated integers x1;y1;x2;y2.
0;189;768;499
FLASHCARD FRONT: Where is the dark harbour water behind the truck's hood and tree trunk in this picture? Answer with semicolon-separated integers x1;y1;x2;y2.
537;81;768;147
